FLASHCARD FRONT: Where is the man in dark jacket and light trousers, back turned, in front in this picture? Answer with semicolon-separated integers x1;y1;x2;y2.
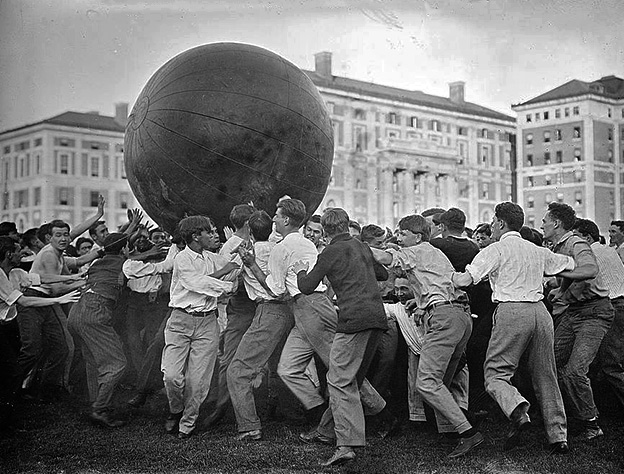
293;208;388;466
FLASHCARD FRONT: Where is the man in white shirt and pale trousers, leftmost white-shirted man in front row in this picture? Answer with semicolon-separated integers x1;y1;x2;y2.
162;216;239;439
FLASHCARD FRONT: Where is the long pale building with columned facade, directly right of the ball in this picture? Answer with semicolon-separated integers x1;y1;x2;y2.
305;52;515;227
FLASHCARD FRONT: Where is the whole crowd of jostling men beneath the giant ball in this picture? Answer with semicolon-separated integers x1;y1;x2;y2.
0;193;624;466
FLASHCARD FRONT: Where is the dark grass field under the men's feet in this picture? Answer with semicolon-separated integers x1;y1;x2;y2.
0;386;624;474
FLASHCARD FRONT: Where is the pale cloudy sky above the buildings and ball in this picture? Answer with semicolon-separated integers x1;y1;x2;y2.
0;0;624;130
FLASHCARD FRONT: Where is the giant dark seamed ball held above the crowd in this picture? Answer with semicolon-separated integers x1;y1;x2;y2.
124;43;334;232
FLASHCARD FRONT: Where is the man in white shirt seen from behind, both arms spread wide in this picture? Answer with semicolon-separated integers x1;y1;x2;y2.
452;202;574;453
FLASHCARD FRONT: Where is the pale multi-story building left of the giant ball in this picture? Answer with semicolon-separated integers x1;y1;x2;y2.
0;104;136;232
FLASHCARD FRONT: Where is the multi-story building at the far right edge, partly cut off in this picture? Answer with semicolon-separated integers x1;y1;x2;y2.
512;76;624;232
